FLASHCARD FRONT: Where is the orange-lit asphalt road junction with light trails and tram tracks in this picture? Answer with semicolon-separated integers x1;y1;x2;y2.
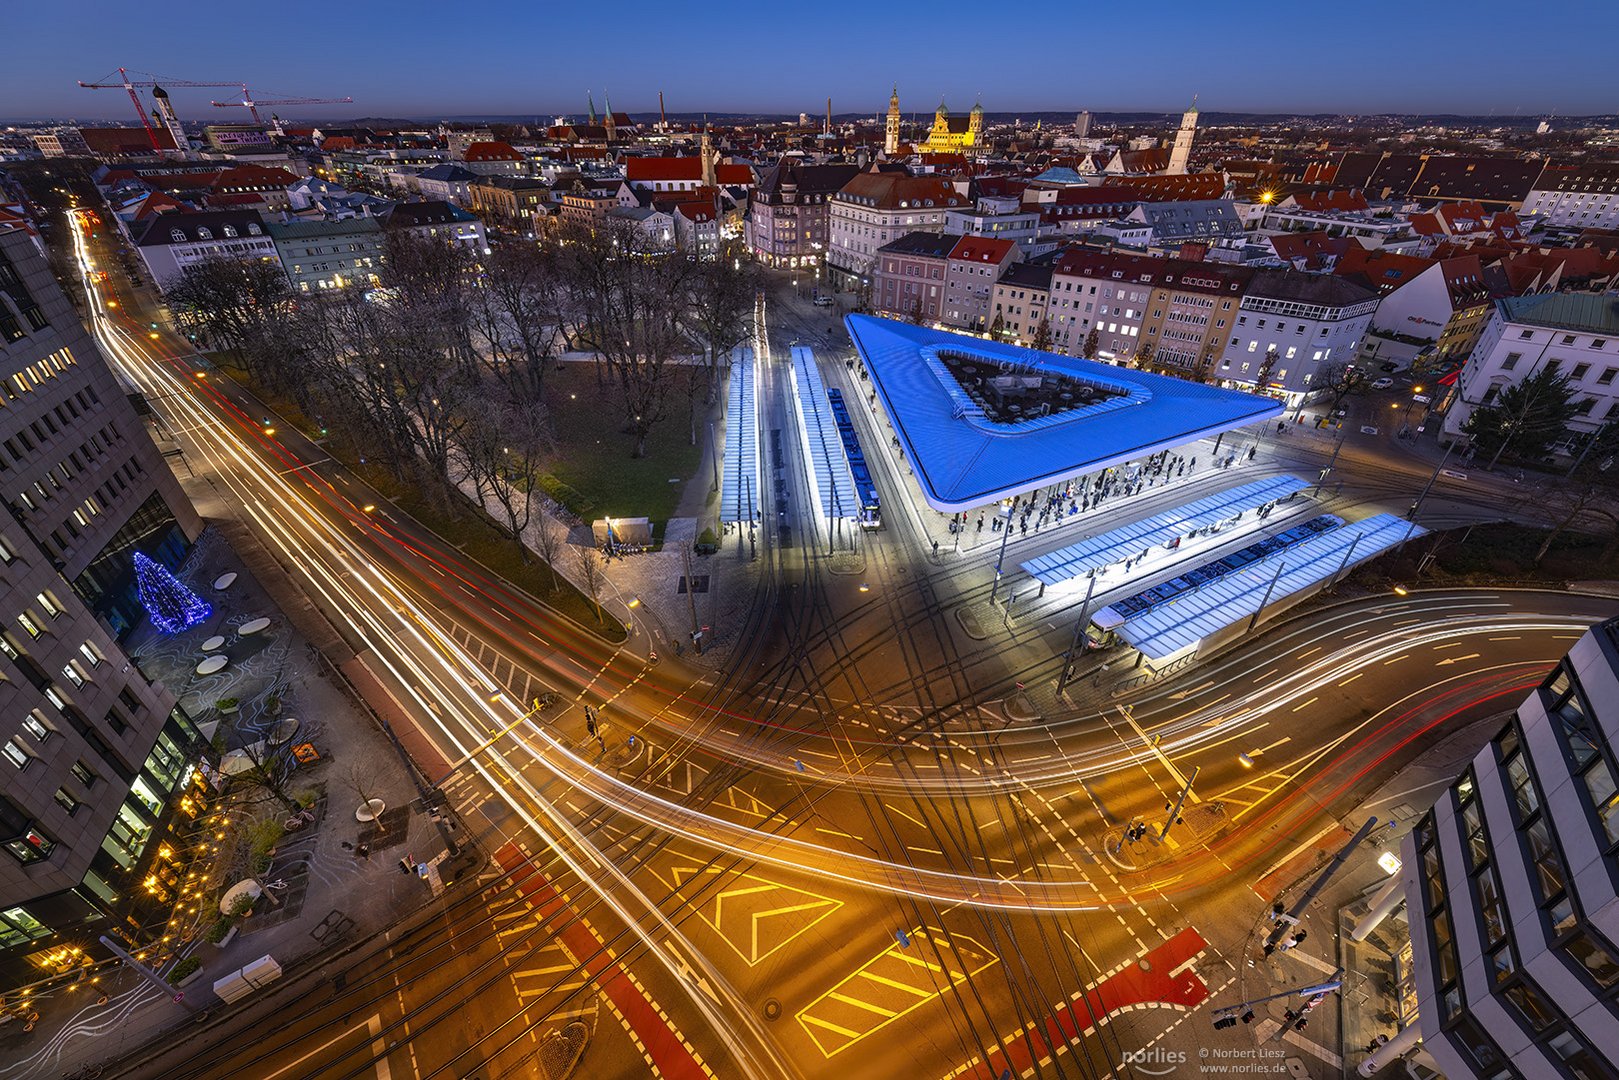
53;233;1616;1077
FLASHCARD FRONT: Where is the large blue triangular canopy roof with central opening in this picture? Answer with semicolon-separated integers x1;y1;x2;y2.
843;316;1282;513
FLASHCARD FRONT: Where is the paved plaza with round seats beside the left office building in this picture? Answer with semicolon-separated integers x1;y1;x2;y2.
0;528;468;1080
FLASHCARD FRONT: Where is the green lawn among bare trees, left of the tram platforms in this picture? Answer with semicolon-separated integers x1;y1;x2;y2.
546;363;708;539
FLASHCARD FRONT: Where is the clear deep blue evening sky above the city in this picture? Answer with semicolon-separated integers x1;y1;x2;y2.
9;0;1619;123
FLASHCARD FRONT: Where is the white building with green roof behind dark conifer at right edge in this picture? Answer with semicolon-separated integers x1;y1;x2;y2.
1444;293;1619;452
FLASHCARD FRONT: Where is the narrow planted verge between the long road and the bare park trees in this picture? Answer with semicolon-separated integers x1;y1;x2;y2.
210;353;624;643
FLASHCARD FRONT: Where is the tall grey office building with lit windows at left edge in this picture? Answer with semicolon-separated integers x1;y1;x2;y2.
0;232;202;986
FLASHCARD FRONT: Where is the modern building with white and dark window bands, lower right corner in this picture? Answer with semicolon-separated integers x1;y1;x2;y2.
1385;620;1619;1080
